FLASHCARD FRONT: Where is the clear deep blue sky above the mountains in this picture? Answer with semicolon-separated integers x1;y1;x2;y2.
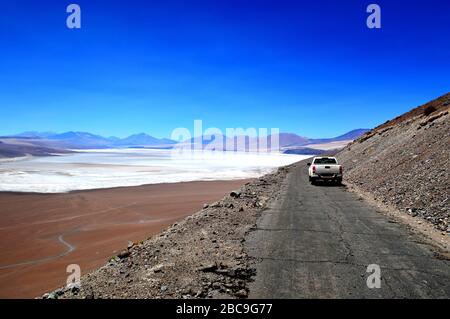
0;0;450;137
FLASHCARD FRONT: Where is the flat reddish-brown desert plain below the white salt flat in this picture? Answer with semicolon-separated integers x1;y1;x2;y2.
0;180;248;298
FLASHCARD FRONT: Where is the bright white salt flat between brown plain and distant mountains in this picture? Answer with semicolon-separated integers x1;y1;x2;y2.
0;149;308;193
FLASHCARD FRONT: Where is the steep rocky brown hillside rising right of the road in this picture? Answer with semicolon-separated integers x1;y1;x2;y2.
337;93;450;232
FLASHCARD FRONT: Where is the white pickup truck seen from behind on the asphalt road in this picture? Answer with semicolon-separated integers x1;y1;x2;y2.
308;157;342;185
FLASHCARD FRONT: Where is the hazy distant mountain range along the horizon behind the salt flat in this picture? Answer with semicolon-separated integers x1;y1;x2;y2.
0;129;369;157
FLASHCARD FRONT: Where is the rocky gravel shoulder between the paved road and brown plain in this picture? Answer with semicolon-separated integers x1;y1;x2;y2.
44;166;292;298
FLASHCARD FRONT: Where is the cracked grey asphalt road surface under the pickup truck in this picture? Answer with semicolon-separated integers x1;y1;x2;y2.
246;162;450;298
